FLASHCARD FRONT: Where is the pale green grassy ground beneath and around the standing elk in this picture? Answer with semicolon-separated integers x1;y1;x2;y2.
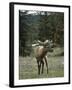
19;48;64;79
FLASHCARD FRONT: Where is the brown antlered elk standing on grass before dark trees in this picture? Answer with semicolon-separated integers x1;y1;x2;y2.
32;40;53;75
